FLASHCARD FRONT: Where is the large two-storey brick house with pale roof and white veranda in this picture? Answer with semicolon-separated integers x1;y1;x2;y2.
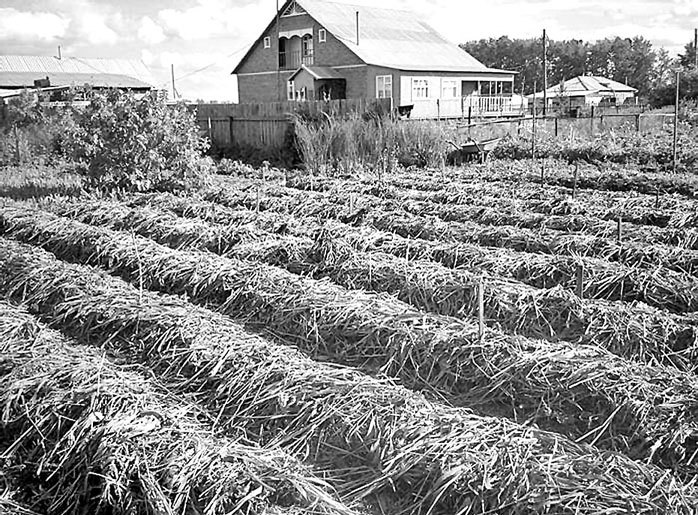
233;0;524;117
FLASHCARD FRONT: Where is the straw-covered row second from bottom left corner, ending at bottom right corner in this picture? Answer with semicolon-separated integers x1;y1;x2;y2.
0;240;698;515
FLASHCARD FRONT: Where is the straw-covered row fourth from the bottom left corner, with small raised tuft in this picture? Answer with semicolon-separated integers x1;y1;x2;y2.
35;196;698;371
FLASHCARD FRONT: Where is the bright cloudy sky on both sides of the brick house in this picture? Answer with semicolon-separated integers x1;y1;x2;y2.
0;0;698;101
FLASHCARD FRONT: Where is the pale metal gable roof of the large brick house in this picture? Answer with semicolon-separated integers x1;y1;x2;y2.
233;0;515;75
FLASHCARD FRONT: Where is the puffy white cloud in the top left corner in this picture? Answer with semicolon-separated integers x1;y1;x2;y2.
0;8;70;42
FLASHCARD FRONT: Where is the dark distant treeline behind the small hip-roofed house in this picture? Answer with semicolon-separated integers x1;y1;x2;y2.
461;36;698;105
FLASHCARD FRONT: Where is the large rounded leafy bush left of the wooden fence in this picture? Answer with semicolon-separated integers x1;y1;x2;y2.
62;90;210;191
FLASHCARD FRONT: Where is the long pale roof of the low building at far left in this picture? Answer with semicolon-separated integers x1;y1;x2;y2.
0;55;155;89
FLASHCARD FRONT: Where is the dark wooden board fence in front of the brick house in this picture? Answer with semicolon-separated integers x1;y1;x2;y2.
196;99;390;150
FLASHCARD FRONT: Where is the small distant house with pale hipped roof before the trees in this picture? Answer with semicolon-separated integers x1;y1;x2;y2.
527;75;637;110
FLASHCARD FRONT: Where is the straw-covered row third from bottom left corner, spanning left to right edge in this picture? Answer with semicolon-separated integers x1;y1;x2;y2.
0;208;698;480
